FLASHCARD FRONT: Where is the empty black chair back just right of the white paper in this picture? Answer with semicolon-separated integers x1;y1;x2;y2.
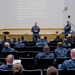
21;58;35;69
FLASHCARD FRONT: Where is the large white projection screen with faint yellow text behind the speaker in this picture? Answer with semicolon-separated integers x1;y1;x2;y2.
0;0;64;28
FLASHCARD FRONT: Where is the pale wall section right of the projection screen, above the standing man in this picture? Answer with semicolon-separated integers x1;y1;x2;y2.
63;0;75;31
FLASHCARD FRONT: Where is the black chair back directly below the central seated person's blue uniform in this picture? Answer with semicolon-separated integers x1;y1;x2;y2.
36;58;54;69
